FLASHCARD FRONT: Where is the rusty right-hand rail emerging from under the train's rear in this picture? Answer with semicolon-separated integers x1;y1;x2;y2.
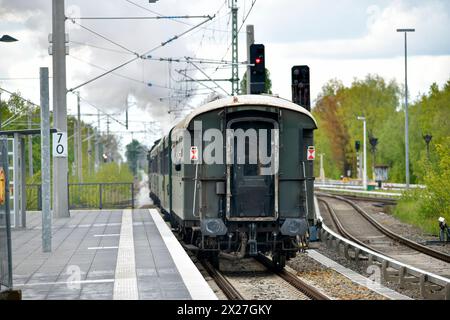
256;254;330;300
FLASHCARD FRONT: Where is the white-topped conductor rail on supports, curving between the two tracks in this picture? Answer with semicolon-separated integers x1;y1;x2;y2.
314;197;450;300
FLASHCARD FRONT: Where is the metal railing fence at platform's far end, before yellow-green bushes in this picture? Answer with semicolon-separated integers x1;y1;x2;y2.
26;182;134;210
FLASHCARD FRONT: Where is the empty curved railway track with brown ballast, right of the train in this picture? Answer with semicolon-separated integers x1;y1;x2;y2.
317;193;450;278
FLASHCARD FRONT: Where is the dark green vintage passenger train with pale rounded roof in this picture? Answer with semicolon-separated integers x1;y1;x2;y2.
147;95;317;269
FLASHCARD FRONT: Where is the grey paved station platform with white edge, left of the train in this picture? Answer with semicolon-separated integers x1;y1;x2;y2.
8;209;217;300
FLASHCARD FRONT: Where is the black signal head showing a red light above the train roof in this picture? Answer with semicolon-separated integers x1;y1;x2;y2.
249;44;266;94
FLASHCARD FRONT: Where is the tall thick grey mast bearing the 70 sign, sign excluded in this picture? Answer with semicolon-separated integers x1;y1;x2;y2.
49;0;70;218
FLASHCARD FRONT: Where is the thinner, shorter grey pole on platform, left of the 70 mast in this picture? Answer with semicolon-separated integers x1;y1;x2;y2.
40;68;51;252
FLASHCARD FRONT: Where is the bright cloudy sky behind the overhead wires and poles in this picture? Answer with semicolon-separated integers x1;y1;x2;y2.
0;0;450;158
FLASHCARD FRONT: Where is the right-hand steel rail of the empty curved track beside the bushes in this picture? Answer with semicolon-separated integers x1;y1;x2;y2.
317;193;450;263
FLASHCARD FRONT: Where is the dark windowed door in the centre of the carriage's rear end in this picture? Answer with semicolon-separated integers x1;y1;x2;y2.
227;118;277;220
